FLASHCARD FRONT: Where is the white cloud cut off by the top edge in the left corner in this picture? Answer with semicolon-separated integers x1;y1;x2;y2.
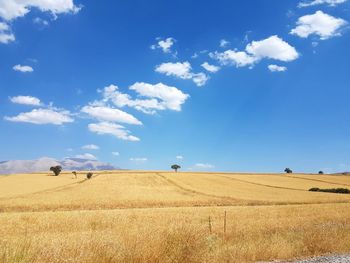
0;0;80;21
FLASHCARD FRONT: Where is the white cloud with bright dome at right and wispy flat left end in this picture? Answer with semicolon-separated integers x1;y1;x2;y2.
209;35;299;67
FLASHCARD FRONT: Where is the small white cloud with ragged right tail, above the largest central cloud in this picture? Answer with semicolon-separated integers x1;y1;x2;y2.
155;61;209;87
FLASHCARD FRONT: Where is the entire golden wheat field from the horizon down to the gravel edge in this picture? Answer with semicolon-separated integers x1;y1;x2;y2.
0;171;350;263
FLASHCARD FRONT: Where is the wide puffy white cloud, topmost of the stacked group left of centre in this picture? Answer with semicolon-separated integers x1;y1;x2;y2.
101;83;189;114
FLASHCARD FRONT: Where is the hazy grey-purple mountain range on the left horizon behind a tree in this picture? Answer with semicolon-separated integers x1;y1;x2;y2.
0;157;120;174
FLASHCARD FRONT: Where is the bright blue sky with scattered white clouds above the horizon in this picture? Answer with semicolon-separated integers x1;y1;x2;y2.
0;0;350;172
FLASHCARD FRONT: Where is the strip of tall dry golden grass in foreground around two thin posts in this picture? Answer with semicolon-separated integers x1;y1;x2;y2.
0;204;350;263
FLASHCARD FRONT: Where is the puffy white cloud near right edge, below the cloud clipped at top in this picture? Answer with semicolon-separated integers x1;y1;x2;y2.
290;11;347;40
